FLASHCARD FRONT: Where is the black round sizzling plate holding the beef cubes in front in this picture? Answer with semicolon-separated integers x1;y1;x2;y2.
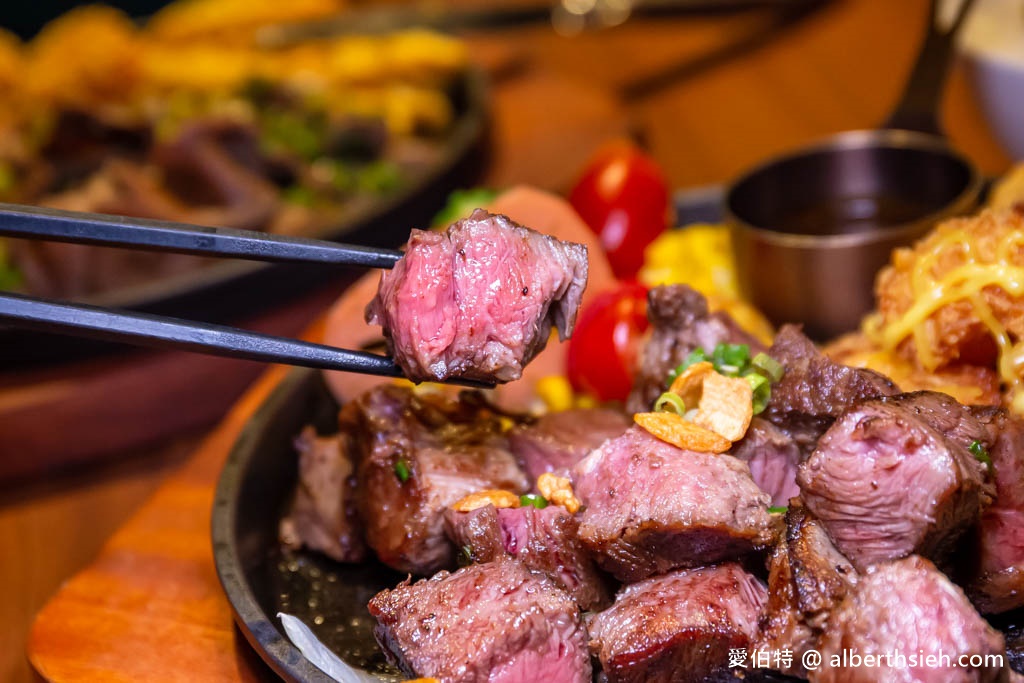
212;187;737;683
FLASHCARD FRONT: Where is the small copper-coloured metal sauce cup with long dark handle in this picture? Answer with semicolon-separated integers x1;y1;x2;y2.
725;0;982;340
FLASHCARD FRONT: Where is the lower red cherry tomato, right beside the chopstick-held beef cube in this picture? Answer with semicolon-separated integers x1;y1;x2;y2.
566;283;647;400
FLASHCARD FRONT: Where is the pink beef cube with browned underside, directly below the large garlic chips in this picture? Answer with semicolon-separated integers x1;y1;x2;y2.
573;427;772;582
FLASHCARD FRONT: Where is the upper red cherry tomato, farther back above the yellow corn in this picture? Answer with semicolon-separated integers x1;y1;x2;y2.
569;141;669;279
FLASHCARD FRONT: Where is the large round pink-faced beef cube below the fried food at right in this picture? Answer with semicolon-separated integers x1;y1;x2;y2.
797;392;989;571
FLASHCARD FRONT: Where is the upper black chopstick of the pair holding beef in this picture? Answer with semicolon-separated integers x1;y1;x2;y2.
0;204;401;268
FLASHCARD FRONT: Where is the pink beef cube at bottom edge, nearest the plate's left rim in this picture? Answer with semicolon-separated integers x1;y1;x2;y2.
369;557;591;683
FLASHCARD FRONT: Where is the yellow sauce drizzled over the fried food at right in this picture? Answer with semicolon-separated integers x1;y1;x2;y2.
863;228;1024;405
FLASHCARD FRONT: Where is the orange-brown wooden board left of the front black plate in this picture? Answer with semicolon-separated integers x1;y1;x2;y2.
28;368;285;682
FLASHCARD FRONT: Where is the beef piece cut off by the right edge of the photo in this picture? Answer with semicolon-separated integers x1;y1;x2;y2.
968;408;1024;613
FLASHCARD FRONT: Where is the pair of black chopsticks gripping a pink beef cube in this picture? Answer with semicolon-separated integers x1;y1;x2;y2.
0;204;490;388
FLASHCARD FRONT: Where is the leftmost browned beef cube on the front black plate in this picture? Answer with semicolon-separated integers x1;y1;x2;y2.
279;427;367;562
